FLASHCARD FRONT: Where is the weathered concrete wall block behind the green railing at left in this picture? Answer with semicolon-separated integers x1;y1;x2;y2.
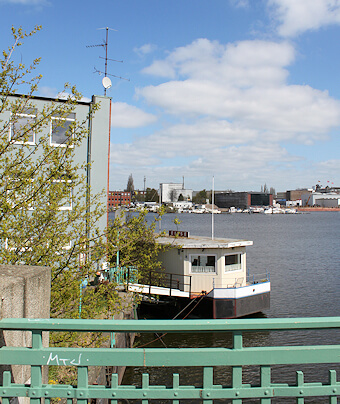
0;265;51;392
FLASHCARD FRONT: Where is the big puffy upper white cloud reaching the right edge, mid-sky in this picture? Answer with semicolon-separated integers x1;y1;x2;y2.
137;39;340;143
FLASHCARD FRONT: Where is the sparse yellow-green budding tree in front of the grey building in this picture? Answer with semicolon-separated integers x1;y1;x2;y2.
0;27;120;324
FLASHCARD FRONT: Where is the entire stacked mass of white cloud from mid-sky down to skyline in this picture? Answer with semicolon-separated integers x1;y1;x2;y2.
111;39;340;190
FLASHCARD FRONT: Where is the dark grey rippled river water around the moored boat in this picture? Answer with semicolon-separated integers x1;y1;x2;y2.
123;212;340;403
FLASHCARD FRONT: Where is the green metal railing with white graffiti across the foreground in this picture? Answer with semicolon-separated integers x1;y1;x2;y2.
0;317;340;404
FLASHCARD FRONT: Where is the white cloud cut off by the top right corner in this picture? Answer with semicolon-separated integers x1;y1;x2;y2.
268;0;340;37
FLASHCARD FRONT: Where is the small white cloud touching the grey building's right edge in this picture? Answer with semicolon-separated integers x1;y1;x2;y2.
111;102;157;128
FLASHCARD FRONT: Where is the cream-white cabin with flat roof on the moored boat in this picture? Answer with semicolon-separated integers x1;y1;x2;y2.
157;236;253;297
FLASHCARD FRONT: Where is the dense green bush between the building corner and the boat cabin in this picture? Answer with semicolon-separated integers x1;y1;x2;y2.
108;208;167;279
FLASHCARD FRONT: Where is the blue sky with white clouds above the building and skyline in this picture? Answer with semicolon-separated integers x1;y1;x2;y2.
0;0;340;191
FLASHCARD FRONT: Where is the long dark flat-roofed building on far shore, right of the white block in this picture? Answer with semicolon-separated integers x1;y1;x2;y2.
215;192;273;209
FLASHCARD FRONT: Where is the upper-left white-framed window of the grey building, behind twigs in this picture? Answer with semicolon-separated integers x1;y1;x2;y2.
9;109;36;145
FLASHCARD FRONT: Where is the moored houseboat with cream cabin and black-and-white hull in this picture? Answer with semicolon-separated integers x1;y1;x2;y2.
138;231;270;319
